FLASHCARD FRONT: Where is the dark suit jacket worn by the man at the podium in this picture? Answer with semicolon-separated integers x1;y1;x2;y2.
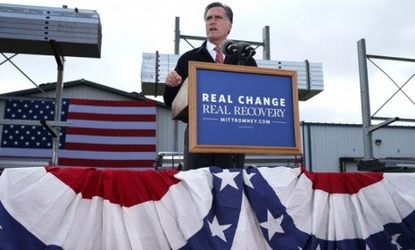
163;41;257;107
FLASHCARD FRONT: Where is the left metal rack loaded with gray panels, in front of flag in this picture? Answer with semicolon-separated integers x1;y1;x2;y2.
0;4;102;165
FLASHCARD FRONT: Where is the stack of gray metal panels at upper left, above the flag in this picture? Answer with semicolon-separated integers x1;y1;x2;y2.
0;4;102;58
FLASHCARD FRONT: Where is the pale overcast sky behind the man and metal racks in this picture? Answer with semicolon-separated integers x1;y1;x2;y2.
0;0;415;125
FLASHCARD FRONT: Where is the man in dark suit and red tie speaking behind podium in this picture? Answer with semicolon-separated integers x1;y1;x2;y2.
164;2;257;170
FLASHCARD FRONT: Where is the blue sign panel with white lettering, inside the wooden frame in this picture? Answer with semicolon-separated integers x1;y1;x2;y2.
196;69;297;147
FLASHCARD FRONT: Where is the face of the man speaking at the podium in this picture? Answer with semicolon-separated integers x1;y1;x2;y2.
205;7;232;45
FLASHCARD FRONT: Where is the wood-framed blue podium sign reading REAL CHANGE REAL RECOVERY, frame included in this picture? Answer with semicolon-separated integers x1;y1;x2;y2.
188;62;301;154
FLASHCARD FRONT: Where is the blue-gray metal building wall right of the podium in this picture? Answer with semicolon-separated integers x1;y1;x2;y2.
302;123;415;172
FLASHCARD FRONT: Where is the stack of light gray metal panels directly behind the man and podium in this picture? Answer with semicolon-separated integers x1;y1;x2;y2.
141;53;324;101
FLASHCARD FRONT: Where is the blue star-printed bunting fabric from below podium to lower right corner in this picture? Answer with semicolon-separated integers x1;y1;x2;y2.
182;168;415;250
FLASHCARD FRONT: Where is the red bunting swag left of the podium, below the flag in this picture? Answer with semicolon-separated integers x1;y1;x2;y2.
46;167;179;207
